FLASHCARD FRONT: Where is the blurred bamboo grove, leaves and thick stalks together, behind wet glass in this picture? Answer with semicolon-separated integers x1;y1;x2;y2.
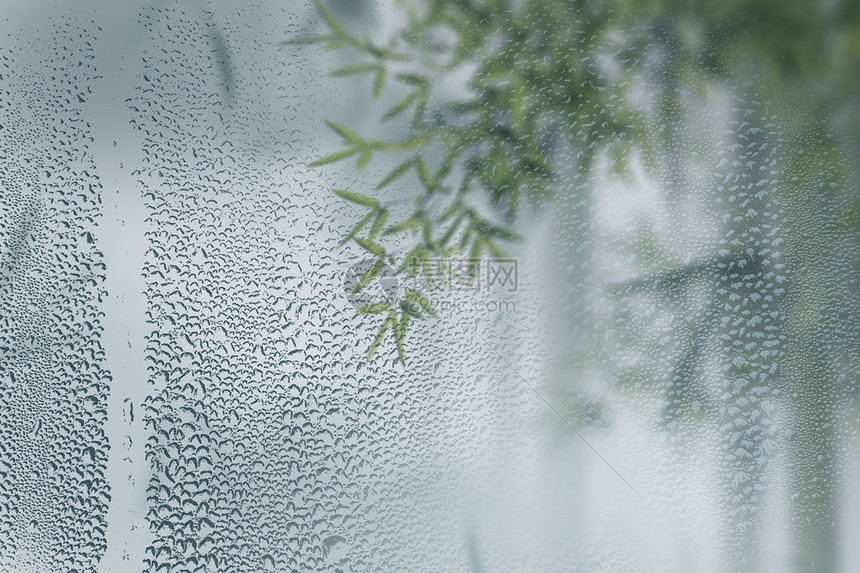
304;0;860;571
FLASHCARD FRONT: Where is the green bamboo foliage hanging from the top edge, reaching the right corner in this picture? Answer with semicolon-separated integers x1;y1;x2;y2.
288;0;860;361
